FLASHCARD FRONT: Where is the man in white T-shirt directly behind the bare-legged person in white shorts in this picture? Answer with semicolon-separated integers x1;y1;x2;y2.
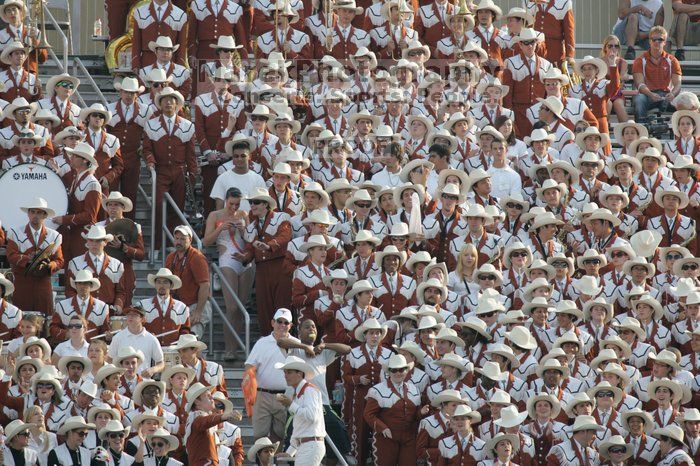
205;135;267;211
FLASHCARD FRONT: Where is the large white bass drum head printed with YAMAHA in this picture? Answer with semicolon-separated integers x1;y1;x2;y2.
0;163;68;230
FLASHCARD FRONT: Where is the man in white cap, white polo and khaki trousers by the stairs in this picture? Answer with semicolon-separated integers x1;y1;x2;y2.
243;308;301;442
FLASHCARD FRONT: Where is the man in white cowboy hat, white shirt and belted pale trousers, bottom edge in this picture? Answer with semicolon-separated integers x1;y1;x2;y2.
275;356;326;466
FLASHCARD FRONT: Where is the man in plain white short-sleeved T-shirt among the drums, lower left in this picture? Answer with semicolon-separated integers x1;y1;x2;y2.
109;307;165;378
